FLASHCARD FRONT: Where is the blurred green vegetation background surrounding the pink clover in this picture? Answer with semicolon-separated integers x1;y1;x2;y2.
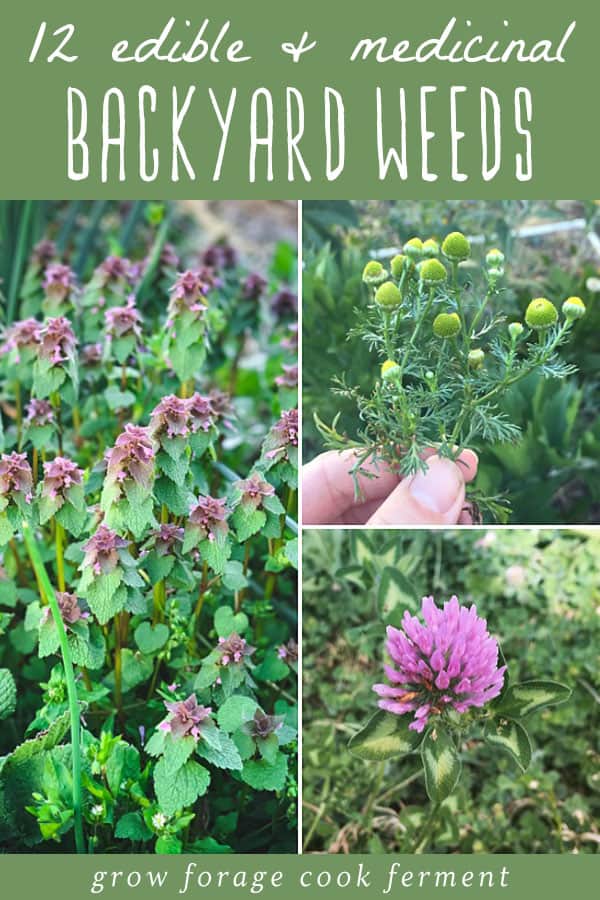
303;529;600;853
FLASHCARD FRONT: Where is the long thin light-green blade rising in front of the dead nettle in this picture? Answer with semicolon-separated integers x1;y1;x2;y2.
23;522;85;853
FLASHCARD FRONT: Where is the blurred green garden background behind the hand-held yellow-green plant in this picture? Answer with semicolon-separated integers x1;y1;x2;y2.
303;200;600;525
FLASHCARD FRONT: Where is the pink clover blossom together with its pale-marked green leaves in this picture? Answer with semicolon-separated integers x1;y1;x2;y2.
349;597;571;828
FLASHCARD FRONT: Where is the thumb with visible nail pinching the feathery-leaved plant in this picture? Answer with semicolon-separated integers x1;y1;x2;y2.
367;456;465;525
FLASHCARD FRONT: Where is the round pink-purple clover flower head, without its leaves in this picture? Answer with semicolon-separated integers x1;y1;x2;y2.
373;597;506;732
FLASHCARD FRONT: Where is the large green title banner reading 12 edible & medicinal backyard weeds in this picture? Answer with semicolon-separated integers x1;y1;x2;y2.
0;0;600;199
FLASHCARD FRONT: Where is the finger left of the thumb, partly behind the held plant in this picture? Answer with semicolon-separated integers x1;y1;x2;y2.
302;450;399;525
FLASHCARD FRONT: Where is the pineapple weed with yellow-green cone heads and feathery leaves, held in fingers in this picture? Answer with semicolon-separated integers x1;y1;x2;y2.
315;232;585;522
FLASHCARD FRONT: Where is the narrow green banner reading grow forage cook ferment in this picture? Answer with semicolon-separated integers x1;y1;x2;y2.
0;855;598;900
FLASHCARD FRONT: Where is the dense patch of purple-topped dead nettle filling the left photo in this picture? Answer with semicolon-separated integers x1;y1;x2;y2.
0;221;297;853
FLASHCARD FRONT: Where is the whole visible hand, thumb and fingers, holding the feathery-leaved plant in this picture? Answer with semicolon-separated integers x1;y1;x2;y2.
302;450;478;526
